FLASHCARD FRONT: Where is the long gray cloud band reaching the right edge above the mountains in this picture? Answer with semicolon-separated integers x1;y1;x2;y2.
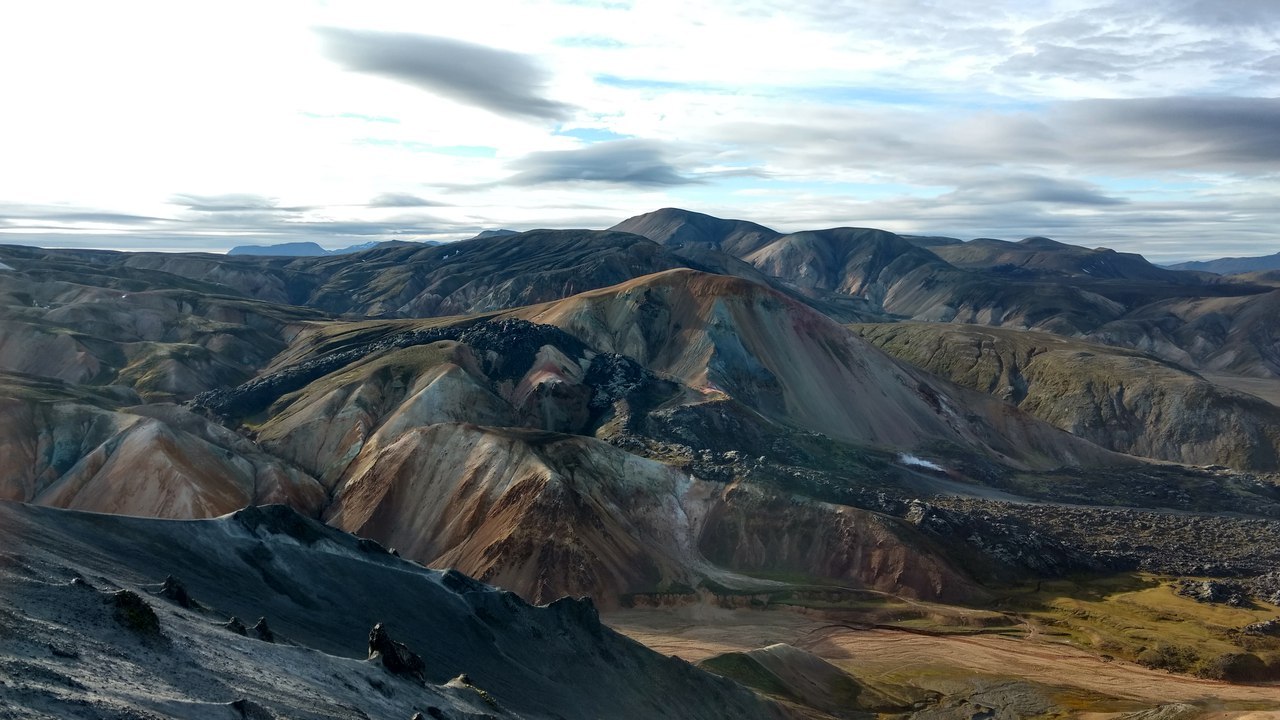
707;97;1280;176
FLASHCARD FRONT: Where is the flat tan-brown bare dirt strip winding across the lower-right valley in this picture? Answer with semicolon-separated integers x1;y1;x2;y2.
604;607;1280;707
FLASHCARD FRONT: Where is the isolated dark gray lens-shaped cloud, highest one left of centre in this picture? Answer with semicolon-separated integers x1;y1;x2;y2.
316;28;573;120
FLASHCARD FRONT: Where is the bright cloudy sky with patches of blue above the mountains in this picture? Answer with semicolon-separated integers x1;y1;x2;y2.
0;0;1280;263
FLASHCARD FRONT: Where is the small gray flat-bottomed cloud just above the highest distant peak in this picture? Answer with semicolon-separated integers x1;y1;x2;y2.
503;140;703;187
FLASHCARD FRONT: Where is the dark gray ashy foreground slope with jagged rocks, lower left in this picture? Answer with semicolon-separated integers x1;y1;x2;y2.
0;502;786;720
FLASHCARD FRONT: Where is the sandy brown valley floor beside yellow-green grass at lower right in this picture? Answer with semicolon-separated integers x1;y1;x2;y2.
604;606;1280;720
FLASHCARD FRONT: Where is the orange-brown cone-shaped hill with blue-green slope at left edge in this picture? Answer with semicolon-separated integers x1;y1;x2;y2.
0;373;325;518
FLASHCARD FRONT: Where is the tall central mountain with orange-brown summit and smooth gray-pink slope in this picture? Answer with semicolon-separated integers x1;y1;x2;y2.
516;270;1121;464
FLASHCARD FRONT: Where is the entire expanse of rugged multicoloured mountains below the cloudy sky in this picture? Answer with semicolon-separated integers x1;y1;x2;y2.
0;209;1280;717
